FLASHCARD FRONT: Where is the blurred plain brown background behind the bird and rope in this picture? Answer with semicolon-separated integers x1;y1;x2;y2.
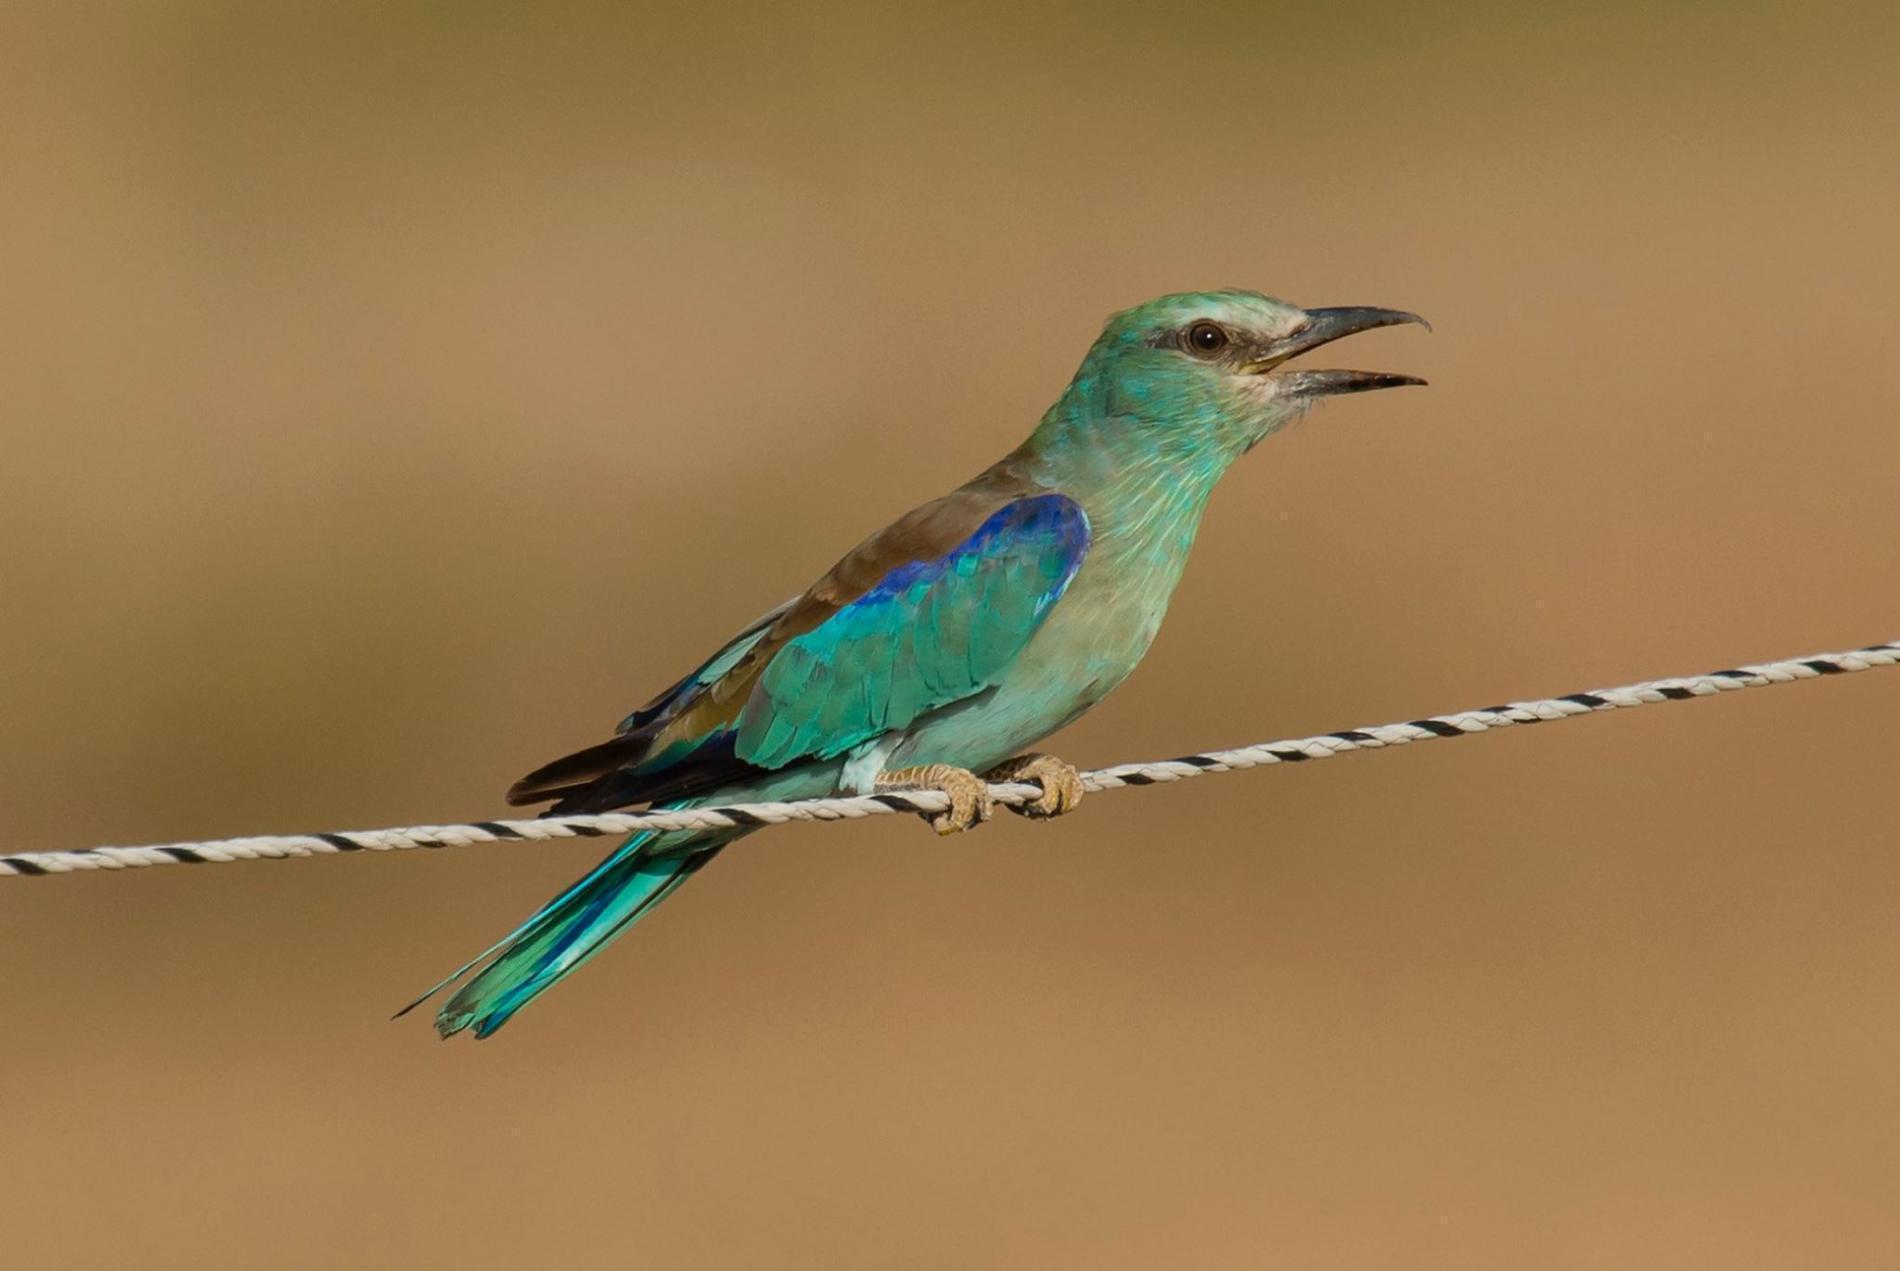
0;4;1900;1269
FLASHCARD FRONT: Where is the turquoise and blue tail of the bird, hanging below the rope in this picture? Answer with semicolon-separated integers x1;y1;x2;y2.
397;830;733;1037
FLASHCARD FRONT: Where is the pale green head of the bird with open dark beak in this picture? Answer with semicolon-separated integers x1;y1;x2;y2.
1045;291;1425;475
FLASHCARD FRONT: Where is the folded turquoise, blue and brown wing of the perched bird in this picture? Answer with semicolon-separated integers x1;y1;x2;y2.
509;481;1089;811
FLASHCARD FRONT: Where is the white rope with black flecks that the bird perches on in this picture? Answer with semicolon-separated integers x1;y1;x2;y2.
0;640;1900;878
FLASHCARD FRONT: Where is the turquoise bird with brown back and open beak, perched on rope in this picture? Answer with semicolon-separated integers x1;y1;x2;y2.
403;291;1423;1037
